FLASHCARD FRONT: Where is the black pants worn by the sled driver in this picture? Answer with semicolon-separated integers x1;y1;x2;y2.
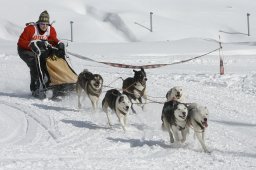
18;47;49;91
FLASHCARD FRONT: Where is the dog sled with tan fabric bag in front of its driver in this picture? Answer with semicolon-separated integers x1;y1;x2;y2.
33;41;78;99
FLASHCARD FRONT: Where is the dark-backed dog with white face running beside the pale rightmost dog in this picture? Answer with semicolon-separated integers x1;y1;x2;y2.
161;101;188;143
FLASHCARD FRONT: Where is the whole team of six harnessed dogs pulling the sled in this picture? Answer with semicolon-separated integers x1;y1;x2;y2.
76;68;209;152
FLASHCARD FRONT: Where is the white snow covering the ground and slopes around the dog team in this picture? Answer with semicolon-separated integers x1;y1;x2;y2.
0;0;256;170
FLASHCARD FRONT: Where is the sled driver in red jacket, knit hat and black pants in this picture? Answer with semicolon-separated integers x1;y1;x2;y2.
17;11;65;98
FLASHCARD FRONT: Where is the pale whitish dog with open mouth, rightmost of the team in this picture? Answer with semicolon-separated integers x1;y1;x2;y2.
186;103;209;152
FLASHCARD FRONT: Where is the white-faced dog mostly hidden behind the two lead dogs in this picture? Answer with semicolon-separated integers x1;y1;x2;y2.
166;86;185;102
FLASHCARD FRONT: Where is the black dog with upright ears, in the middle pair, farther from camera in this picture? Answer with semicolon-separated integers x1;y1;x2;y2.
122;68;147;113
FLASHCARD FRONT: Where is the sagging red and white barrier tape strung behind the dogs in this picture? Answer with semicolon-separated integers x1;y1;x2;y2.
67;47;221;69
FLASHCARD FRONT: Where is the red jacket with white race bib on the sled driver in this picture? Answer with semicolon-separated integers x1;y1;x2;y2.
17;25;59;51
